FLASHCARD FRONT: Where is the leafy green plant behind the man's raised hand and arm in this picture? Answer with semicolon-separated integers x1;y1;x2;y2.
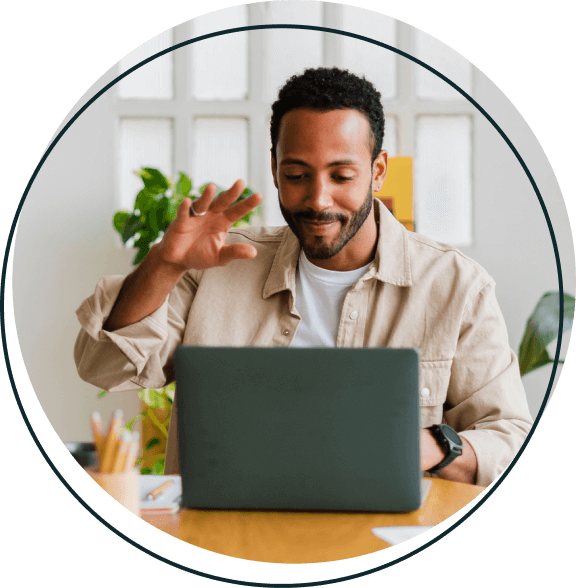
99;167;261;475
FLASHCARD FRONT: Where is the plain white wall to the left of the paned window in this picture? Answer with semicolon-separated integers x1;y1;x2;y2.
12;68;139;441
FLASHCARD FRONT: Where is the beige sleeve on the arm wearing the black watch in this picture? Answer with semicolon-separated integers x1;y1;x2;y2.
444;280;534;486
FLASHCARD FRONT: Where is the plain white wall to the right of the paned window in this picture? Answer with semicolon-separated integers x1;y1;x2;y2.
463;72;576;417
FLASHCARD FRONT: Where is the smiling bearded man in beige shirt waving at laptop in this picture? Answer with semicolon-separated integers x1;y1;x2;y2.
75;68;532;486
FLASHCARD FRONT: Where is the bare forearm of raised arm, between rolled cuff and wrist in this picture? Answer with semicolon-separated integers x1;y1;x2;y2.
104;245;184;331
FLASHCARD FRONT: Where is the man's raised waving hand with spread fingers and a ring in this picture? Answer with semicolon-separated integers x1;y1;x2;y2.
158;180;262;271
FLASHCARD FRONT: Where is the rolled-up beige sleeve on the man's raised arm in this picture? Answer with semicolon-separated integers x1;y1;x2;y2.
74;274;197;392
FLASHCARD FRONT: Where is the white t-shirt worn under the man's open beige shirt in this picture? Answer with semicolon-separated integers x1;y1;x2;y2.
291;250;372;347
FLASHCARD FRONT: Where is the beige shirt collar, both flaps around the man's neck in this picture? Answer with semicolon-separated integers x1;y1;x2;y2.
262;198;412;298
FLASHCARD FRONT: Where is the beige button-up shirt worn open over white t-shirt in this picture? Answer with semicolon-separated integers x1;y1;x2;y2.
74;200;533;486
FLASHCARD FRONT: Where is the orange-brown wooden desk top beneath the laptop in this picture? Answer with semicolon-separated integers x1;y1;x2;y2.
141;478;484;564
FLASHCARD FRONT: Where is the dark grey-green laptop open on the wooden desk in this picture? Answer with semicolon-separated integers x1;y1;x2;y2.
174;346;430;512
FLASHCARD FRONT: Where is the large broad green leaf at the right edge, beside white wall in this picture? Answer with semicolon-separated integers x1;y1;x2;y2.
518;292;575;376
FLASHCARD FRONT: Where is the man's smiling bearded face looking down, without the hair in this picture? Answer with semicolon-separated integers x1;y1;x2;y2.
272;109;385;259
